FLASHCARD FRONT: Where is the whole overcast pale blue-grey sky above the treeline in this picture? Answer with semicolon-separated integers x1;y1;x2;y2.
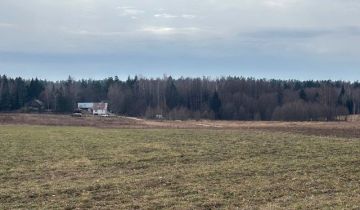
0;0;360;80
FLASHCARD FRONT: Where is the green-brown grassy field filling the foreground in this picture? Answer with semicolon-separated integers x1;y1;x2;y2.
0;125;360;209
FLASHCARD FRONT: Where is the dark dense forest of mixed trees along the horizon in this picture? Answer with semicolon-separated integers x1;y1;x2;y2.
0;75;360;121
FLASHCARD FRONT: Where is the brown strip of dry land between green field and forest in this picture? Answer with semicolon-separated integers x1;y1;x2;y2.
0;114;360;138
